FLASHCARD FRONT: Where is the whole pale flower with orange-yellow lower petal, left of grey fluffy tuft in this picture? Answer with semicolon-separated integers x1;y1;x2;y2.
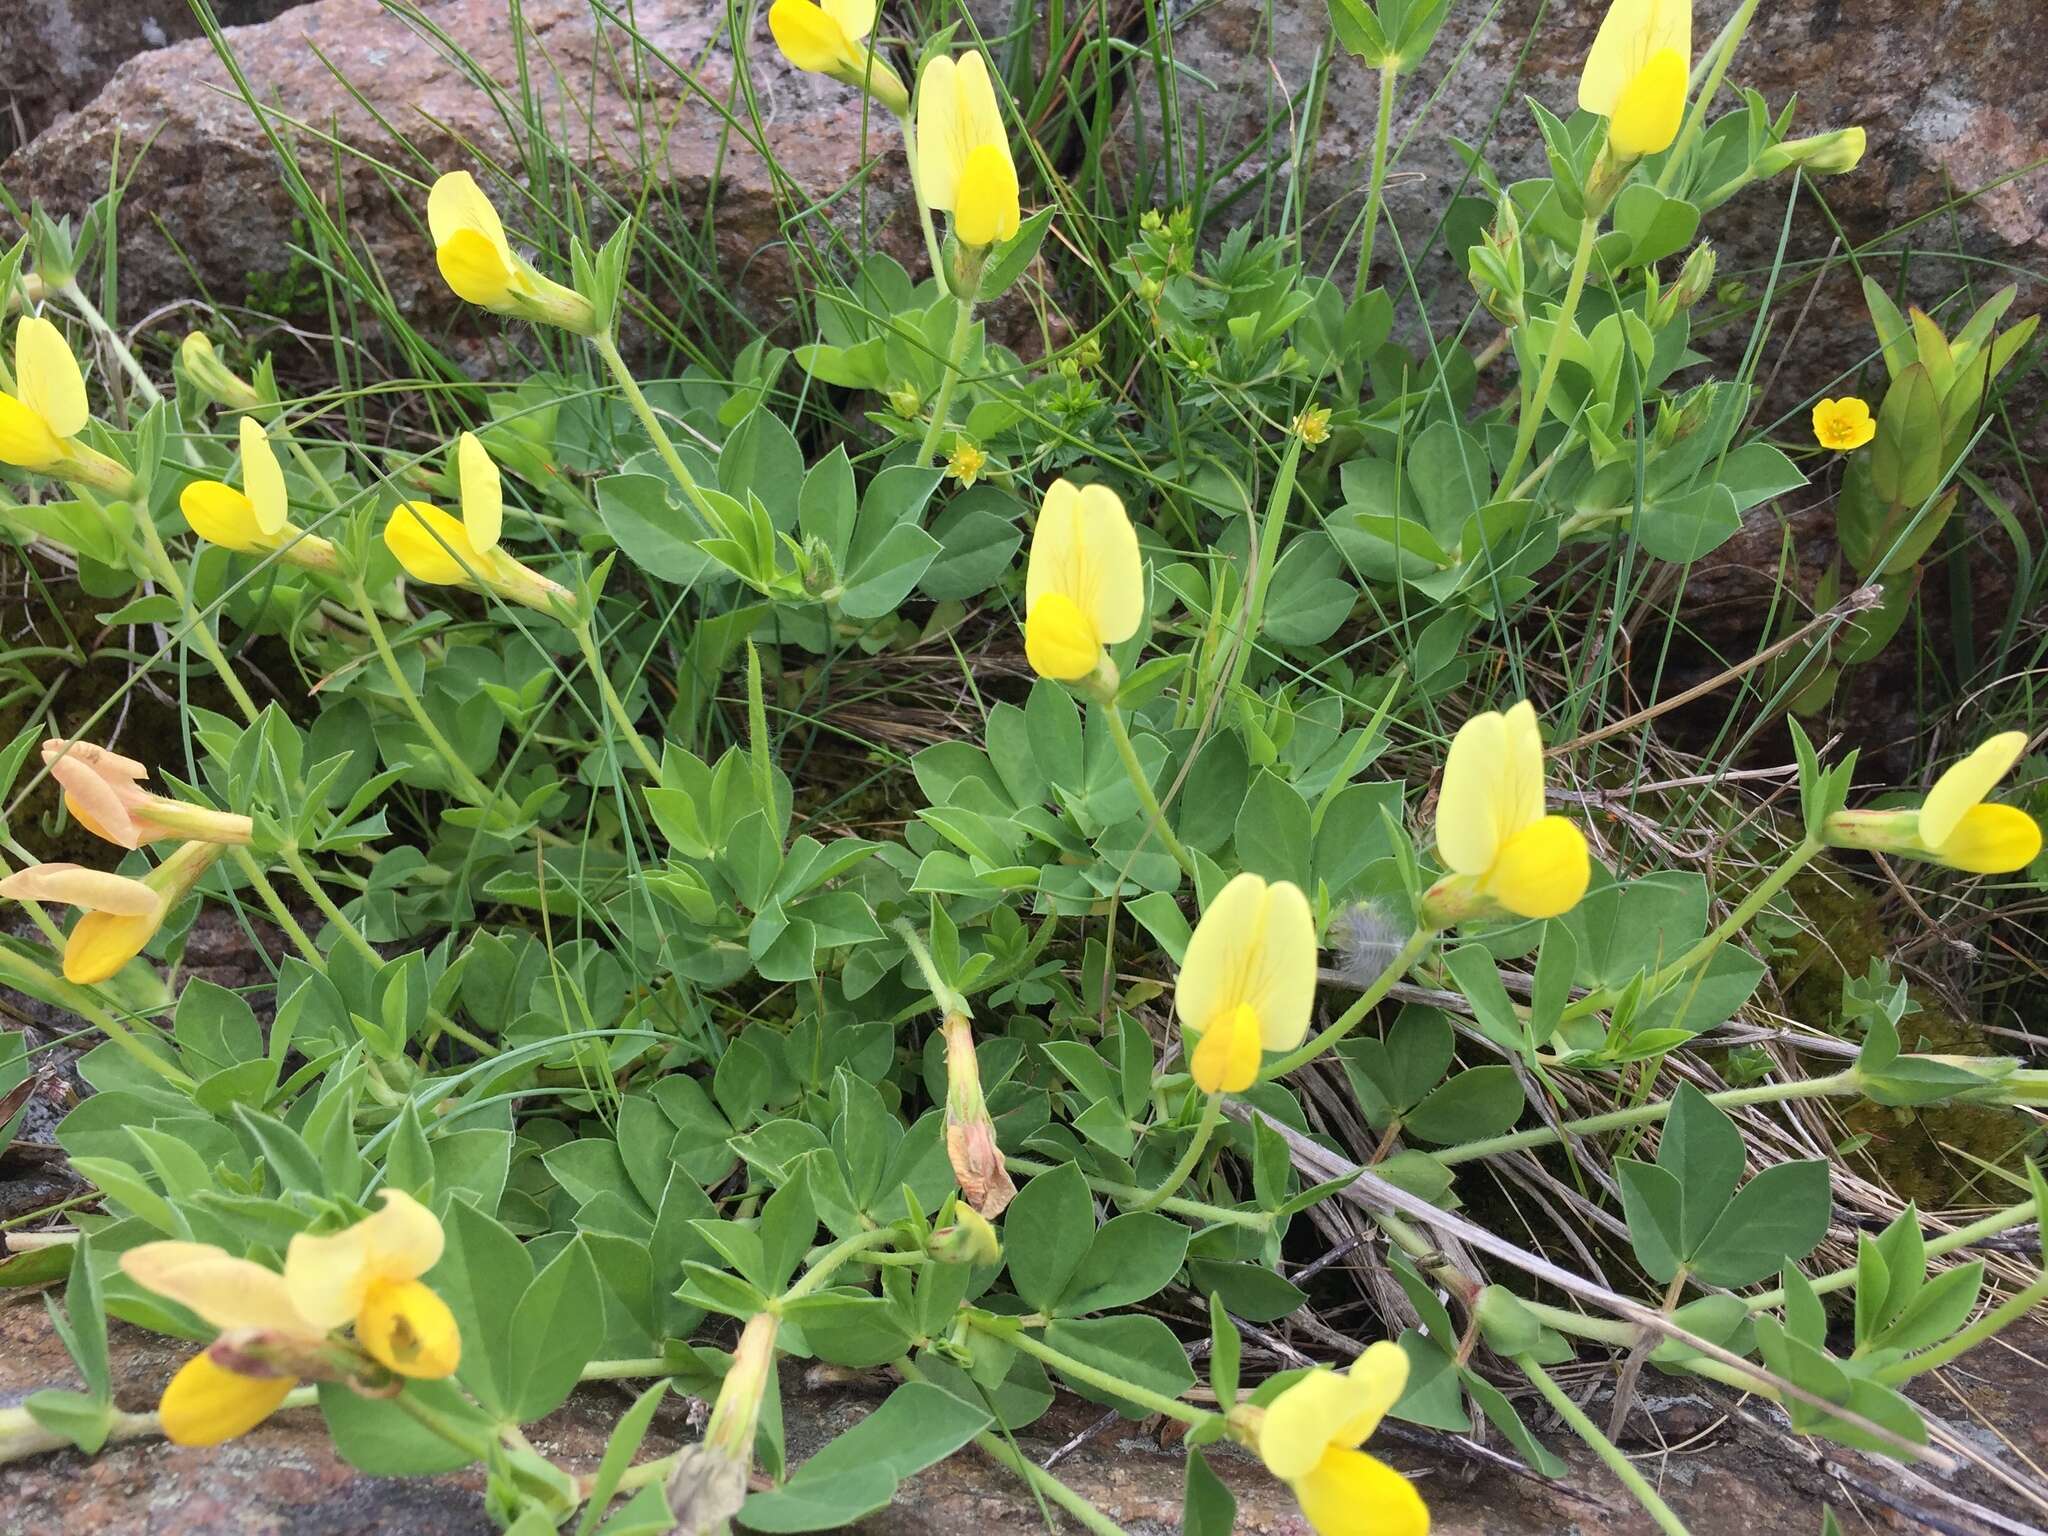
1174;874;1315;1094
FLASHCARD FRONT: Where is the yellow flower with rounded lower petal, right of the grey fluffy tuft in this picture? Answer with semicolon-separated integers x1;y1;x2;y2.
1425;698;1591;926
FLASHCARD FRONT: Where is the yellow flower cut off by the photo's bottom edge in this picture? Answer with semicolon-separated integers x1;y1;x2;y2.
1257;1339;1430;1536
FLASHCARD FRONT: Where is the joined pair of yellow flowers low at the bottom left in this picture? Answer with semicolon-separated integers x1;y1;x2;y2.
121;1190;461;1446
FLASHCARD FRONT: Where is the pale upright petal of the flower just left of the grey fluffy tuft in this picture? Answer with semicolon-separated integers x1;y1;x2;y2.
1174;872;1317;1051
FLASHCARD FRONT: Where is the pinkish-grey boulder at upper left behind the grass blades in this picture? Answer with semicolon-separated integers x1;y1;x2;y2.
0;0;922;339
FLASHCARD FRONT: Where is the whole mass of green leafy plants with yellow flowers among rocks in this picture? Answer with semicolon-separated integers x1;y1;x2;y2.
0;0;2048;1536
